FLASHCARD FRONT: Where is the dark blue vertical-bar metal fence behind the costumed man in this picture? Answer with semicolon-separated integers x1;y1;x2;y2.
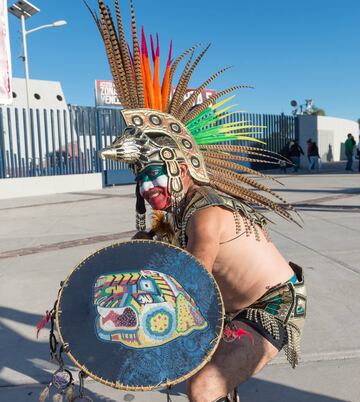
0;106;296;179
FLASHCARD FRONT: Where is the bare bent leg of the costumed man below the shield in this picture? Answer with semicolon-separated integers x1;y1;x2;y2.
187;322;278;402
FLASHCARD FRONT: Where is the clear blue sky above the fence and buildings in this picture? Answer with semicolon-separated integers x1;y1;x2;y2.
4;0;360;120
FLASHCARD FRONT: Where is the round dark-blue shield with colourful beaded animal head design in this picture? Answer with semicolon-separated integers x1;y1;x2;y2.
56;240;224;391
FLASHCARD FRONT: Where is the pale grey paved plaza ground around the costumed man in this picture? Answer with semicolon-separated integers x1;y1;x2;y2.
0;165;360;402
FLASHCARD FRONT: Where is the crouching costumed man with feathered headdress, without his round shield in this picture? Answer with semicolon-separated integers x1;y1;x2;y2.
86;0;306;402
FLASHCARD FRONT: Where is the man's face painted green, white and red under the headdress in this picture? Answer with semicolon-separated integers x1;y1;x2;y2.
135;165;171;210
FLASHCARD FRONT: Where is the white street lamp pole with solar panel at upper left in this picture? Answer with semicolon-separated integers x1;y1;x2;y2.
8;0;66;114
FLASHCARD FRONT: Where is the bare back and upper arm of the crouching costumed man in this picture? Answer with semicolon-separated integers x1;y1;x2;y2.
187;187;294;312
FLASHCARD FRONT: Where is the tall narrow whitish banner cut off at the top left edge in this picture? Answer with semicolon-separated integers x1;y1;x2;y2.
0;0;12;105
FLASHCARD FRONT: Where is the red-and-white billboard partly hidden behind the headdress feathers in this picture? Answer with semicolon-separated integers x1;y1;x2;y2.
95;80;216;107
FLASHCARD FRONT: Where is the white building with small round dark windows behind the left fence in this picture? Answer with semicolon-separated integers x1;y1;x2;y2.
2;78;88;174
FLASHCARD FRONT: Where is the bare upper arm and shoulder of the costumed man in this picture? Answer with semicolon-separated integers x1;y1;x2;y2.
186;207;221;272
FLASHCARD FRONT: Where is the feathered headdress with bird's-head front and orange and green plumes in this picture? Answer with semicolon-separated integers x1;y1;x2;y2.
85;0;294;230
